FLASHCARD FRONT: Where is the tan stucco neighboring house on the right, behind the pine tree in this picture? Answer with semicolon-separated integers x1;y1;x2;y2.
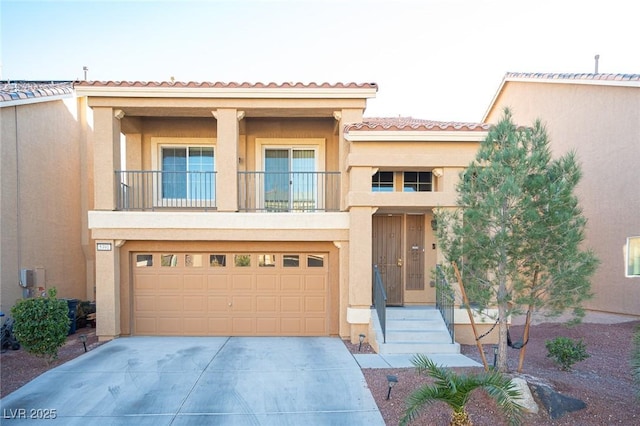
484;73;640;316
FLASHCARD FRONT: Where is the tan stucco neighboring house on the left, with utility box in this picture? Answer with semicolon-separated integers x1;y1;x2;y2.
0;82;94;314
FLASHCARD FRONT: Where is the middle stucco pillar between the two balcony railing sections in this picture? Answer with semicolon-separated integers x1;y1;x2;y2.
212;108;244;212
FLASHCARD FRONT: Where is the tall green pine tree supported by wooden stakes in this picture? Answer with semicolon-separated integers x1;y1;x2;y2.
436;109;598;371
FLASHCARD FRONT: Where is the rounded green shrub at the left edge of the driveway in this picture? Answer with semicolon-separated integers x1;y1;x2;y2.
11;288;69;364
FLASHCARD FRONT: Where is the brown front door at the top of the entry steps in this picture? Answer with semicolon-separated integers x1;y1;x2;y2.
372;215;404;306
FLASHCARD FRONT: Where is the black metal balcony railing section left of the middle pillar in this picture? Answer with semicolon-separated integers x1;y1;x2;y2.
115;170;216;210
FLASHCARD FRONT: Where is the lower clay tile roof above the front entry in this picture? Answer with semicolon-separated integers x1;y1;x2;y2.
345;117;490;132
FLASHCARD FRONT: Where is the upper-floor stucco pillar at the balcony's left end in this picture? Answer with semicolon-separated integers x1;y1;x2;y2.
93;107;123;210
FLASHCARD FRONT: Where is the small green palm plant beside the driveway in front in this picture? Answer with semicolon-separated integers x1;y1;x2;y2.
400;354;522;426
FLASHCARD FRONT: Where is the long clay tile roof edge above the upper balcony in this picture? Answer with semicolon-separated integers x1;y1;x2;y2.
75;81;378;90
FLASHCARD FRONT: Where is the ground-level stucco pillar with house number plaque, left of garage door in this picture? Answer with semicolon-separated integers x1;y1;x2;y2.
96;240;120;341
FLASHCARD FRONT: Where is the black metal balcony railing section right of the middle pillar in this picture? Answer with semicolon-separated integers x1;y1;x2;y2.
238;172;340;212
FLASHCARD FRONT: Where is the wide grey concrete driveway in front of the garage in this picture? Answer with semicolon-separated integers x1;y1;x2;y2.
0;337;384;426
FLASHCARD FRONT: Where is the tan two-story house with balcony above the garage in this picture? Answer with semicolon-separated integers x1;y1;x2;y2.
75;82;488;342
